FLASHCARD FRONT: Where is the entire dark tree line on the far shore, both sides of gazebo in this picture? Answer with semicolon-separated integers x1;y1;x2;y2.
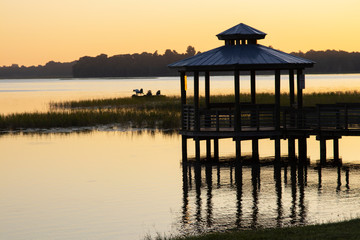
0;46;360;78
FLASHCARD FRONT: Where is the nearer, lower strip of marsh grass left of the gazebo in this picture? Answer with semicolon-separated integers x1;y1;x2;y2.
0;109;180;130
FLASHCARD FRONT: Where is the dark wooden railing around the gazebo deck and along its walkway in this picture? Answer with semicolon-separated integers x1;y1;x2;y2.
182;103;360;131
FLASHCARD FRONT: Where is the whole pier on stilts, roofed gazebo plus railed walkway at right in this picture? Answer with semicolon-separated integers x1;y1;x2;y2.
169;24;360;161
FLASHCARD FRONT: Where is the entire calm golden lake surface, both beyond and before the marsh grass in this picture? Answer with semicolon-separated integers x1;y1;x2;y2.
0;75;360;240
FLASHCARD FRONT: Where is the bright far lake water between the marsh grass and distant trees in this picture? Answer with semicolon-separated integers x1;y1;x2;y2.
0;74;360;113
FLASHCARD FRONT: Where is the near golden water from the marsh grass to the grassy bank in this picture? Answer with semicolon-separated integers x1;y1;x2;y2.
0;131;360;240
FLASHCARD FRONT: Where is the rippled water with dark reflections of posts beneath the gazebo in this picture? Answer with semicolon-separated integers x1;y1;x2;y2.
179;159;350;233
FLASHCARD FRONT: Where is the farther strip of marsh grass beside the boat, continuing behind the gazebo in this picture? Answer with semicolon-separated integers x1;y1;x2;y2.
50;91;360;111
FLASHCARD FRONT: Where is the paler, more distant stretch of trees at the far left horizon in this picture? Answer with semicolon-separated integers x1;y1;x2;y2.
0;61;75;78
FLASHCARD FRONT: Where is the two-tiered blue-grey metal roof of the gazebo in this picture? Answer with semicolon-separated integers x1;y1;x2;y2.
168;24;314;71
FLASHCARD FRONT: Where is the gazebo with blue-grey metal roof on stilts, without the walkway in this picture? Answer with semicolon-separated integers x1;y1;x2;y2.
168;23;314;161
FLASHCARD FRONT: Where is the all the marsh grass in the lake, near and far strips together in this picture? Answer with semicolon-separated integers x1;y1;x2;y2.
0;91;360;131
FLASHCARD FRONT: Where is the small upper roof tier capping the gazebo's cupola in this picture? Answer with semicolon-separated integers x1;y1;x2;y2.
216;23;266;40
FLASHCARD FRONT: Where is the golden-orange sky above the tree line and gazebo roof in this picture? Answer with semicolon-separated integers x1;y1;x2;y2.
0;0;360;66
